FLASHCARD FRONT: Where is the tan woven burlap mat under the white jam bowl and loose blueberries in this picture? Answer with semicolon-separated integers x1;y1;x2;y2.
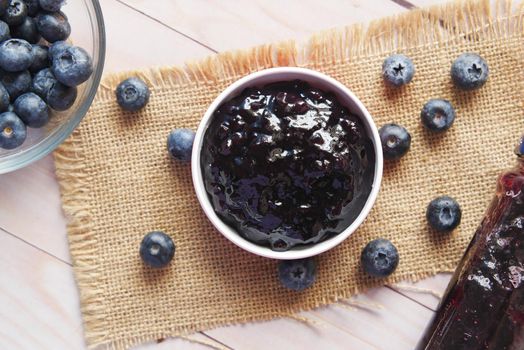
55;1;524;349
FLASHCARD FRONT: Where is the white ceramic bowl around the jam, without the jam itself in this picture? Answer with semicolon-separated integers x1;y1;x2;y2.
191;67;383;260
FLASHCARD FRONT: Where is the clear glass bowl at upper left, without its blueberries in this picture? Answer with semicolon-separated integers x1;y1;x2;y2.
0;0;106;174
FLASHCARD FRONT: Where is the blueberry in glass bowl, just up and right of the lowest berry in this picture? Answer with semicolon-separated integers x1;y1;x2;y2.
14;92;49;128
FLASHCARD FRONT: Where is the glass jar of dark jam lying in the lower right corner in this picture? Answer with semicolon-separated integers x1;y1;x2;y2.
419;166;524;350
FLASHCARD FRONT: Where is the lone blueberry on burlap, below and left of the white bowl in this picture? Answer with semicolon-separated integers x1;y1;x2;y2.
140;231;175;267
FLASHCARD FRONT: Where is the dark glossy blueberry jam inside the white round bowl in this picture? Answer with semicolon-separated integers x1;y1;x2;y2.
201;80;375;251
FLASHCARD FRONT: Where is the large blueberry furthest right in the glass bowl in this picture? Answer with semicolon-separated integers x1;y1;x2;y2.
51;46;93;86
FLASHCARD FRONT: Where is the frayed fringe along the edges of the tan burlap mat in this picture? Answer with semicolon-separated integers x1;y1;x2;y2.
54;0;524;349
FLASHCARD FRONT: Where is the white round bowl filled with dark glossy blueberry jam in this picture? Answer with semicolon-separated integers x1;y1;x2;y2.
191;67;383;259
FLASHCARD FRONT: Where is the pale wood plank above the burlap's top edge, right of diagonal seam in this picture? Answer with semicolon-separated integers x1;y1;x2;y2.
118;0;406;51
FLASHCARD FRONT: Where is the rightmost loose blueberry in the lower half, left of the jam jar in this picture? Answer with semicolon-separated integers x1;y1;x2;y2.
426;196;462;232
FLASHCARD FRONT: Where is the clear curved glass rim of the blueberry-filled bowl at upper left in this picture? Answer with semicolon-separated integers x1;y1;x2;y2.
0;0;106;174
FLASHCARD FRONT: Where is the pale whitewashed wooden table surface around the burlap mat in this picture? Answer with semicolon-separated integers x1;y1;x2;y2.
0;0;456;350
